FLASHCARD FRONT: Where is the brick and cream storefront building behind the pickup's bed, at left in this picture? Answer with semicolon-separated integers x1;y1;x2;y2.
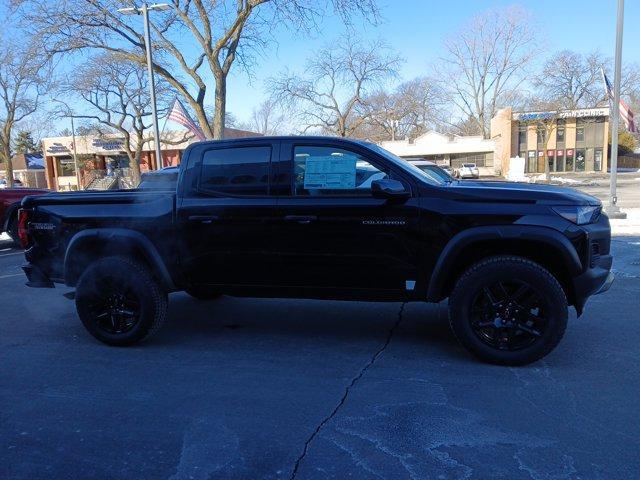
42;128;260;190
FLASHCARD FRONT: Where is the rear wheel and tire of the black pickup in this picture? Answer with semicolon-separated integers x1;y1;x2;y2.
76;256;167;346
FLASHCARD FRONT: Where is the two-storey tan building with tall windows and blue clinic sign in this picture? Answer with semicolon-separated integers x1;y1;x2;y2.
491;107;609;173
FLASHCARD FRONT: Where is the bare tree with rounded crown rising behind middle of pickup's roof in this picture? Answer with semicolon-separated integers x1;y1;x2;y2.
268;36;401;137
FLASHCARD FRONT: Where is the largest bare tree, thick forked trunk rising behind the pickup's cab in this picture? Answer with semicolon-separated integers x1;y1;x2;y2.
19;0;377;138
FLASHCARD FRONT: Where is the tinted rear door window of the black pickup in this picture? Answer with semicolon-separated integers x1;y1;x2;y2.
199;146;271;196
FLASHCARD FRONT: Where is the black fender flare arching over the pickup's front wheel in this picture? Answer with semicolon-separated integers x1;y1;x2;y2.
427;225;582;302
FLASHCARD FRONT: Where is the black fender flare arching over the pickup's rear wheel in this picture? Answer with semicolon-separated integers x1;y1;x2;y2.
64;228;176;291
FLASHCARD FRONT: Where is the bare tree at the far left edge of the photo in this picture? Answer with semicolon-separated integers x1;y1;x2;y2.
0;38;50;187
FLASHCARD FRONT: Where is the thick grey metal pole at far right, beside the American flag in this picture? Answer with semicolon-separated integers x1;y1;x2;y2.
605;0;627;218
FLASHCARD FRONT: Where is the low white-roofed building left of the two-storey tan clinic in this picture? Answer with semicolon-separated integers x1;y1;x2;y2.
380;130;499;175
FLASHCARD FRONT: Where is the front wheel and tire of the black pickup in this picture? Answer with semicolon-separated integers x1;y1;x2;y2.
449;256;568;366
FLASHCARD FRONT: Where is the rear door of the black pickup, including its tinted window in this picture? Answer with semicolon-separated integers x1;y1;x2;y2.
177;140;279;286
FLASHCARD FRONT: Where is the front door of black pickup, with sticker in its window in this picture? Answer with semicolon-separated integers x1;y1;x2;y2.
275;141;419;292
